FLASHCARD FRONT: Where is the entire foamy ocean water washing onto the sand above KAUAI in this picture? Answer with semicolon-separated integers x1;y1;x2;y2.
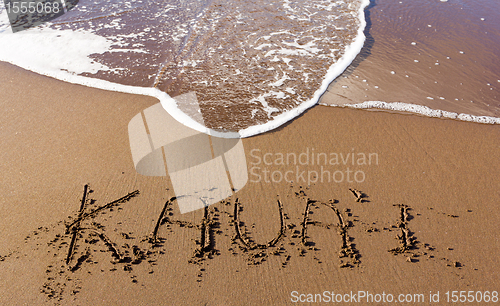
0;0;500;137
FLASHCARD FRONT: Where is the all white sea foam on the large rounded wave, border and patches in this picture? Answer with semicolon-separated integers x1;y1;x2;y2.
0;0;369;137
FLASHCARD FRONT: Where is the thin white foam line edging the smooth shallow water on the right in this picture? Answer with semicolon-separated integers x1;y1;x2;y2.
321;101;500;124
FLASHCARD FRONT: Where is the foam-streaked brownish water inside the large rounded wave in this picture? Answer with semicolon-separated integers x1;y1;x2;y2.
0;0;364;131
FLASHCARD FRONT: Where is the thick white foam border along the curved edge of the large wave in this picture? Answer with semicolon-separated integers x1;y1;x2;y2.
0;0;370;138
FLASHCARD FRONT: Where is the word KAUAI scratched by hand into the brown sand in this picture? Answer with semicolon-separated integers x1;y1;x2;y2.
26;185;465;301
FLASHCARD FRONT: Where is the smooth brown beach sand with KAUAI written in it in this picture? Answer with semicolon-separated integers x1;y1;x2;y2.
0;63;500;305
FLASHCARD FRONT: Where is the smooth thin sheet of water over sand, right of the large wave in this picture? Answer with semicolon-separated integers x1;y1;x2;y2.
321;0;500;117
